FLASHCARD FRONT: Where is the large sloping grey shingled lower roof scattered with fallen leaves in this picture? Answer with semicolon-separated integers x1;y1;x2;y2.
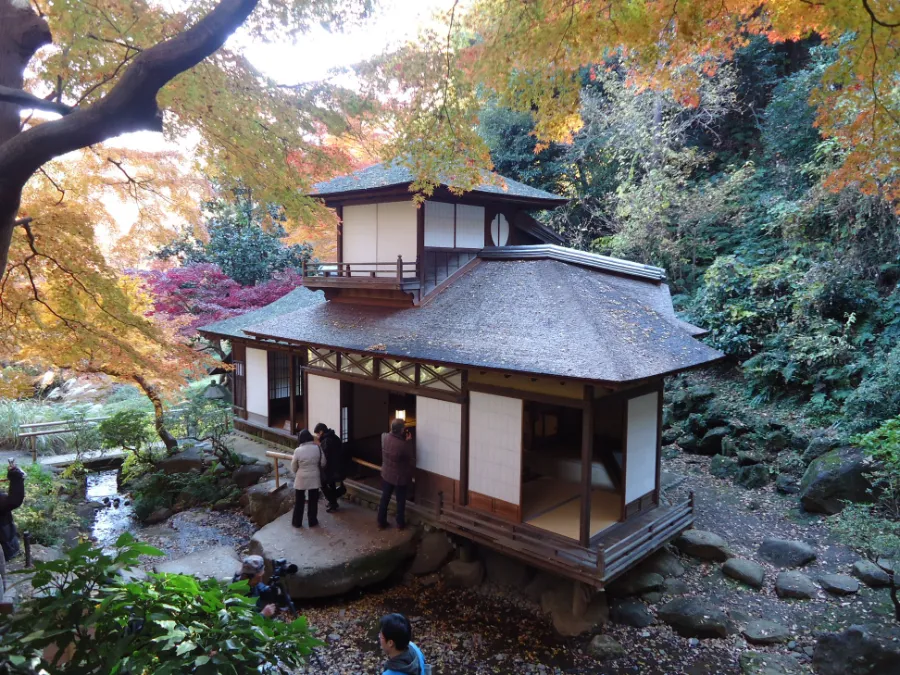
245;259;722;383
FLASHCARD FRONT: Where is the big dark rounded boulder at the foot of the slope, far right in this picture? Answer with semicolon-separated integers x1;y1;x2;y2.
800;447;873;514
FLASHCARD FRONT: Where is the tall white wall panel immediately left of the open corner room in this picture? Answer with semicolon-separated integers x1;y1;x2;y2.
469;391;522;504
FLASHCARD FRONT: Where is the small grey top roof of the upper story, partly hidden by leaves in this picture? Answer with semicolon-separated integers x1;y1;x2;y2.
310;160;568;207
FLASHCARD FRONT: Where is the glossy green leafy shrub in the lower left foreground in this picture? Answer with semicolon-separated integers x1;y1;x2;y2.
0;533;319;675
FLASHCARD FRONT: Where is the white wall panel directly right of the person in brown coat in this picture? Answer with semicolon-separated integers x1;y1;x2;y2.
416;396;462;480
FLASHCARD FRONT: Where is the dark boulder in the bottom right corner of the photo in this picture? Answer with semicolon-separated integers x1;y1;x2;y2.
813;625;900;675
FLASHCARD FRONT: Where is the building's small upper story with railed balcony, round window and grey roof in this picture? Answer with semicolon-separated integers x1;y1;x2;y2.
303;162;567;305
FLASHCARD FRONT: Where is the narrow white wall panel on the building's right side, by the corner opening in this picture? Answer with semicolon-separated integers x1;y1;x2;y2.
625;392;659;503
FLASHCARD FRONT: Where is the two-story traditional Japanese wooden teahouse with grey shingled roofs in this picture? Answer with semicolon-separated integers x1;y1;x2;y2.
200;165;721;587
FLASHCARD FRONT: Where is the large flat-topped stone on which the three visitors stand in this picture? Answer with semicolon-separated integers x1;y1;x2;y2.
250;504;415;598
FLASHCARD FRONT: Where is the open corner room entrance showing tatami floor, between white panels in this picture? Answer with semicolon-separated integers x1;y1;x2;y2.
522;401;622;539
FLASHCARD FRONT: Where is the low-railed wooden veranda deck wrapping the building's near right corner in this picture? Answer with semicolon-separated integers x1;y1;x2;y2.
347;481;694;588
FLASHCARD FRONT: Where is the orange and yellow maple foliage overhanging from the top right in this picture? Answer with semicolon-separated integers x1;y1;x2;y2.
362;0;900;202
